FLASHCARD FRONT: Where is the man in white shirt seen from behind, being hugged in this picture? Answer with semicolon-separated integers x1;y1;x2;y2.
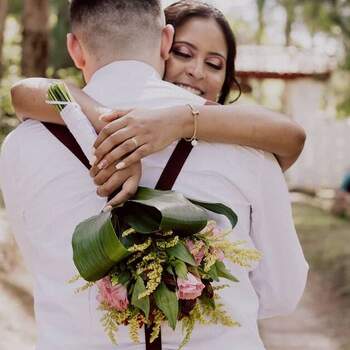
0;0;307;350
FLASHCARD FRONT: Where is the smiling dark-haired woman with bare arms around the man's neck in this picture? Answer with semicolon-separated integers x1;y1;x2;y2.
12;0;305;205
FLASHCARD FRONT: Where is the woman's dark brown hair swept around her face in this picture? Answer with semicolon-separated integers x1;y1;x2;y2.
165;0;242;104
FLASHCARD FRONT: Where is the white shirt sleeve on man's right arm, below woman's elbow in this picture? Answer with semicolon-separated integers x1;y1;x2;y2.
250;153;308;319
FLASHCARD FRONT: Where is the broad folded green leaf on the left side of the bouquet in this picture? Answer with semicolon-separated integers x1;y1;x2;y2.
72;213;130;282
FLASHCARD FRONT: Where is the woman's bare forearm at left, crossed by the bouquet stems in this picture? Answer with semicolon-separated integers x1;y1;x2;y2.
11;78;110;132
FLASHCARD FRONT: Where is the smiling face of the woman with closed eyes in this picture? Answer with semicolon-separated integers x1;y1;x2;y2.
165;17;228;101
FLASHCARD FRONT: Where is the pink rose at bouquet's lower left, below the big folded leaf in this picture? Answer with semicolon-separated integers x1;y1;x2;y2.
97;276;129;311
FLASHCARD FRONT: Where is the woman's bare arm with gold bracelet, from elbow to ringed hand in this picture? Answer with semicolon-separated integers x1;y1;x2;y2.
93;104;306;174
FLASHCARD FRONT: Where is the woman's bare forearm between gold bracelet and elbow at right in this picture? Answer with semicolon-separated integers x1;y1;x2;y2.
189;104;306;171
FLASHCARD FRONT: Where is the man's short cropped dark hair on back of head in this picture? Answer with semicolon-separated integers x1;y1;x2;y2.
70;0;164;55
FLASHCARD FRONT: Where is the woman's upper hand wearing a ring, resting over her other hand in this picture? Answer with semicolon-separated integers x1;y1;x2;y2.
94;106;192;171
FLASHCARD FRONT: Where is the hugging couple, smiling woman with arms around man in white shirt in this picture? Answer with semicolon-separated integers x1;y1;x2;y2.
0;0;308;350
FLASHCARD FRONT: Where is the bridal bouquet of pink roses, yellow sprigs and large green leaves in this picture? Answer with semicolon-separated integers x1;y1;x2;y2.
49;85;261;348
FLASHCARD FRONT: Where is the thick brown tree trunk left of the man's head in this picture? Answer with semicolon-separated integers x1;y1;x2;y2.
21;0;49;77
